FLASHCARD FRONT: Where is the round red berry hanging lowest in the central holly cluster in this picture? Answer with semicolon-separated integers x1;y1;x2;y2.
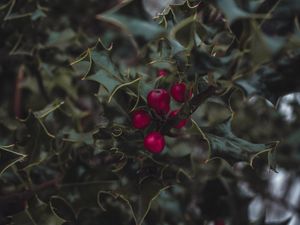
144;131;166;153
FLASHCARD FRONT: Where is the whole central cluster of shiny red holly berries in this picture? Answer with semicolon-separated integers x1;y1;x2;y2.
132;70;191;153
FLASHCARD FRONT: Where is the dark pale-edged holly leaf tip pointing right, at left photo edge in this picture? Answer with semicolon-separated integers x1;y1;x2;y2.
0;146;26;176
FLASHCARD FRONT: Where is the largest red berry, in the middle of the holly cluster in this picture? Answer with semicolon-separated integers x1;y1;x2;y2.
147;89;171;115
